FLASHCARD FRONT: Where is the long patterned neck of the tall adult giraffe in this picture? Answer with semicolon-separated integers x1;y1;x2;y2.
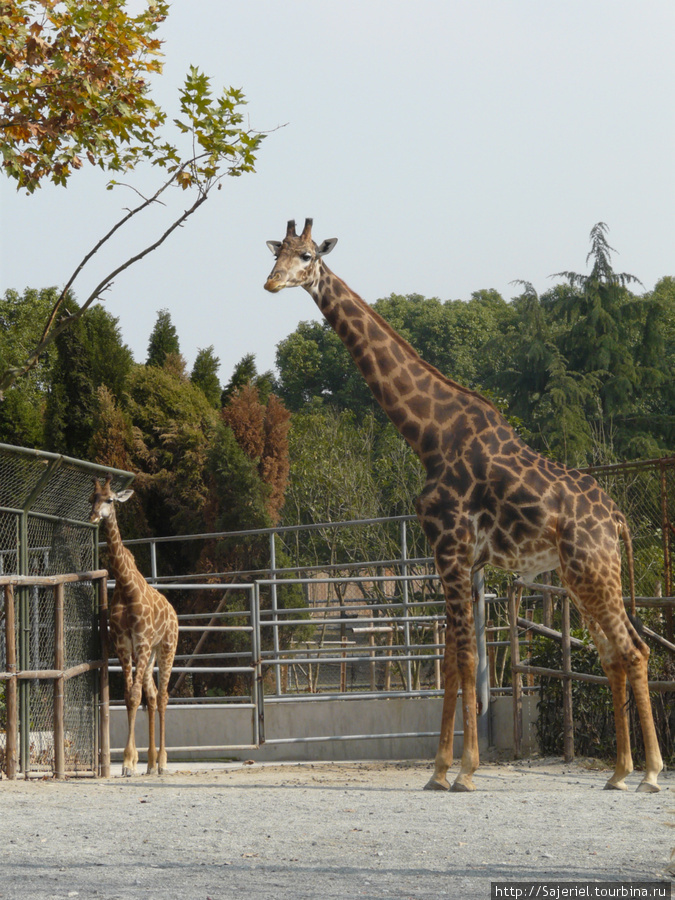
306;260;499;469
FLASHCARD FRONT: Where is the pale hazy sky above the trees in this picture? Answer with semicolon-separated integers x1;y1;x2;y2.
0;0;675;383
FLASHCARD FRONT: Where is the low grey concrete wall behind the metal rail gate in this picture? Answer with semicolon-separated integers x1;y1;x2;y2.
110;697;537;762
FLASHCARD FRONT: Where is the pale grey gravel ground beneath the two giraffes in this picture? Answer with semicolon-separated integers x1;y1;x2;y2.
0;759;675;900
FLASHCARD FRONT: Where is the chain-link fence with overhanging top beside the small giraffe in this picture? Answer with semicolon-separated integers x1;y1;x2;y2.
0;444;134;775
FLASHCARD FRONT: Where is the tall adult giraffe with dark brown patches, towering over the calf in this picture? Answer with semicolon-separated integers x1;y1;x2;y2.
265;219;663;791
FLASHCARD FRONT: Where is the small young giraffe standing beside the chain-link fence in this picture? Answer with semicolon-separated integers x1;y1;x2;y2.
89;475;178;775
